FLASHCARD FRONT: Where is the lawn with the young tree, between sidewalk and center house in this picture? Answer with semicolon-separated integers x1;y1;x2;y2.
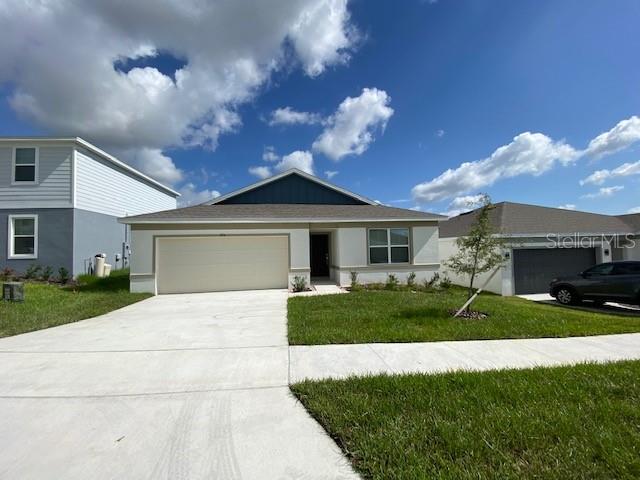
288;288;640;345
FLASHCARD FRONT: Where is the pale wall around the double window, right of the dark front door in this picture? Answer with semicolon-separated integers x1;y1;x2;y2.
324;222;439;286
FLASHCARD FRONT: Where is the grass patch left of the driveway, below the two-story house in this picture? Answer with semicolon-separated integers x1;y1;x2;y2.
0;270;150;337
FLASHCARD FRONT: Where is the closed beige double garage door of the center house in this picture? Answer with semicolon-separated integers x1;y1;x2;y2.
156;236;289;293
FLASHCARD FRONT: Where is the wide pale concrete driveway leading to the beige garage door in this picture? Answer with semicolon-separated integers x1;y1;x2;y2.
0;290;357;480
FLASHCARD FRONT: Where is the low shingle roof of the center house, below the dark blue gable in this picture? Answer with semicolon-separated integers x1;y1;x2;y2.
120;204;445;224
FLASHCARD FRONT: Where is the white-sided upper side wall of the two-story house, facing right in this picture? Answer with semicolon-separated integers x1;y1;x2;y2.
75;148;176;217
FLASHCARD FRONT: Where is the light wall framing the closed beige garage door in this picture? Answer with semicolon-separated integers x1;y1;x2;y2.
131;224;311;294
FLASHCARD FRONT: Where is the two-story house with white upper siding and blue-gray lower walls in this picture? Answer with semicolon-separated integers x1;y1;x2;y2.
0;137;179;276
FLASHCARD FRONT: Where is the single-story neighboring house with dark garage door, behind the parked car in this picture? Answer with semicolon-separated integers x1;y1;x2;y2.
440;202;640;295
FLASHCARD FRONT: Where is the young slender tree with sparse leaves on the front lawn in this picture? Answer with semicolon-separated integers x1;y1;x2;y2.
444;195;504;310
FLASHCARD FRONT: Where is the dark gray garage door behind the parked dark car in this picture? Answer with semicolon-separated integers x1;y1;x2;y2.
513;248;596;295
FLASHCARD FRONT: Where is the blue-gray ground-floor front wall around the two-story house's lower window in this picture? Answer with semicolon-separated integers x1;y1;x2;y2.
0;208;73;275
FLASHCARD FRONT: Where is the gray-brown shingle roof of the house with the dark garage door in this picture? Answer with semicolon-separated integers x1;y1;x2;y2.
440;202;640;238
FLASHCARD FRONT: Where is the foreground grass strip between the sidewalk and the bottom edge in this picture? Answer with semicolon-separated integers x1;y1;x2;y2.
291;361;640;480
